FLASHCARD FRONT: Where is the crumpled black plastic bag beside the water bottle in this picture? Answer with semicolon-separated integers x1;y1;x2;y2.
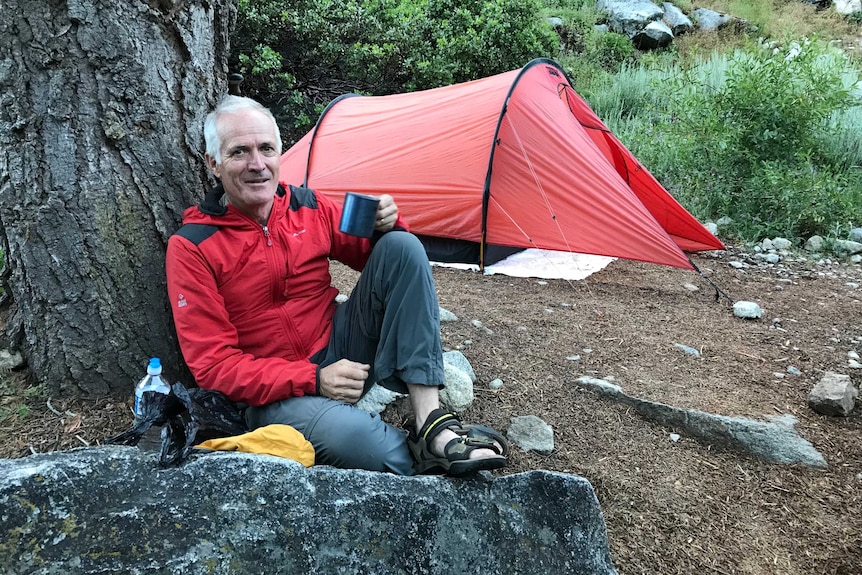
105;383;248;467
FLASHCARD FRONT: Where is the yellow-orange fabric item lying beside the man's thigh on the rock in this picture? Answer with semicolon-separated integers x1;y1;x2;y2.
196;423;314;467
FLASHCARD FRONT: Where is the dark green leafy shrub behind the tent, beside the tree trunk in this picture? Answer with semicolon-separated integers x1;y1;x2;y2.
231;0;559;143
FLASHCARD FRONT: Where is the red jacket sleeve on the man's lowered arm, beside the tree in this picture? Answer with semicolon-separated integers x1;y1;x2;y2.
165;235;317;405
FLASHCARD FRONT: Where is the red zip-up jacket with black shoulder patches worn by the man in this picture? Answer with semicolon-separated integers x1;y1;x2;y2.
166;186;406;405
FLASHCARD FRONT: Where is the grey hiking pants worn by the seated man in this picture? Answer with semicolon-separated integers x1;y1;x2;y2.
246;232;445;475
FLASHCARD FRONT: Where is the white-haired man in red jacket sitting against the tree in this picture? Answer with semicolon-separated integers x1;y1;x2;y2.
166;96;507;476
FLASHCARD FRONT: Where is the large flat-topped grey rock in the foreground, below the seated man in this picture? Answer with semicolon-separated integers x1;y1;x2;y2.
0;446;615;575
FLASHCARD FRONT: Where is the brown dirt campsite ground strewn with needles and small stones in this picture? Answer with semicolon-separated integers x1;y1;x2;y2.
0;250;862;575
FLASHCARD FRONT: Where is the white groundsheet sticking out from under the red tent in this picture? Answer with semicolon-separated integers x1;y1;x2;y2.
431;249;616;280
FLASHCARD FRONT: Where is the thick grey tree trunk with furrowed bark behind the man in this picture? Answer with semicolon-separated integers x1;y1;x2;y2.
0;0;235;396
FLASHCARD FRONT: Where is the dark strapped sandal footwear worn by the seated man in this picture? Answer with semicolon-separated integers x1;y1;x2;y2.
407;409;509;477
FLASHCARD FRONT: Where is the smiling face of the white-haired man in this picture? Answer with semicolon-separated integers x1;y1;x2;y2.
207;110;280;221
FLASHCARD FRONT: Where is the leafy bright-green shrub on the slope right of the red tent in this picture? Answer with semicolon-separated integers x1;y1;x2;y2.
632;37;862;239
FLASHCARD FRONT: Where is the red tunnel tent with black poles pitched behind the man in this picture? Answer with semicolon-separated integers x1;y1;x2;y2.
281;59;724;268
